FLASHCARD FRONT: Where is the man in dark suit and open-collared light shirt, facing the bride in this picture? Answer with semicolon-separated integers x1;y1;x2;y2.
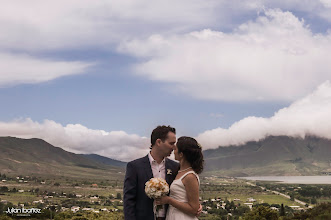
124;126;179;220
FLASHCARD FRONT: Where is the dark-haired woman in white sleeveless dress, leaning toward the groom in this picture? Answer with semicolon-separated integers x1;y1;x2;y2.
156;137;204;220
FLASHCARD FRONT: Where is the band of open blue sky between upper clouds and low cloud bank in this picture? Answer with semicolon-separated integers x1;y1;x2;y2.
0;51;284;136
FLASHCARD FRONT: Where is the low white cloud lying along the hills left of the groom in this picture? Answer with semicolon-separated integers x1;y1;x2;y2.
0;118;150;161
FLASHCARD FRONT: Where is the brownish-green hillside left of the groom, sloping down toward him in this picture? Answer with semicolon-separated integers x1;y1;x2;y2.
0;137;124;178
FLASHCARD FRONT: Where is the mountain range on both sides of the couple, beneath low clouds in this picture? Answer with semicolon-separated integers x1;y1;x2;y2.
0;136;331;178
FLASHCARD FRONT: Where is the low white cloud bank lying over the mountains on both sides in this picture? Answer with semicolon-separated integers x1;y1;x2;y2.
0;81;331;161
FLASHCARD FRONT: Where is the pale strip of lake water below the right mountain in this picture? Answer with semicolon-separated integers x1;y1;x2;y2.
238;176;331;184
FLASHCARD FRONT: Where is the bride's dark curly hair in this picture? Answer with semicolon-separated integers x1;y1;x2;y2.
176;136;204;174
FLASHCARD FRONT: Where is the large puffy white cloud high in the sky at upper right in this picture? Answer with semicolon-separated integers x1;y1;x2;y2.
119;10;331;101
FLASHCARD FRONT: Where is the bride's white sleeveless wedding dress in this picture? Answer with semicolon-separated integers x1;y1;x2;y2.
166;171;200;220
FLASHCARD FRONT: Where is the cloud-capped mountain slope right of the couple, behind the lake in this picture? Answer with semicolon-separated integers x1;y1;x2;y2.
204;136;331;176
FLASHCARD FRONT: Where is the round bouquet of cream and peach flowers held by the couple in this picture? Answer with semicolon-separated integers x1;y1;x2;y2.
145;177;169;217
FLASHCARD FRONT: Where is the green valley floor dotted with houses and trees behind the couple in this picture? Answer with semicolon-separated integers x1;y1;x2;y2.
0;171;331;219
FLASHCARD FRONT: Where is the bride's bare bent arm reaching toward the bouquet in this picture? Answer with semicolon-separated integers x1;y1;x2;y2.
157;174;200;215
